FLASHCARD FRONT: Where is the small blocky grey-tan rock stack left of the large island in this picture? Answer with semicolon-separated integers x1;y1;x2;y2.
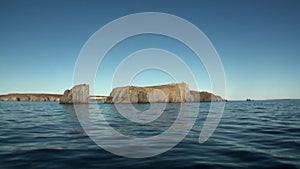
60;84;89;104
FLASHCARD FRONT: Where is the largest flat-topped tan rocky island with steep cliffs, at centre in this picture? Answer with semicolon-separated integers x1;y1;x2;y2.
106;82;222;103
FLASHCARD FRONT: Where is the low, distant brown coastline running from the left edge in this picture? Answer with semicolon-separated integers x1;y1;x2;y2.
0;93;62;101
